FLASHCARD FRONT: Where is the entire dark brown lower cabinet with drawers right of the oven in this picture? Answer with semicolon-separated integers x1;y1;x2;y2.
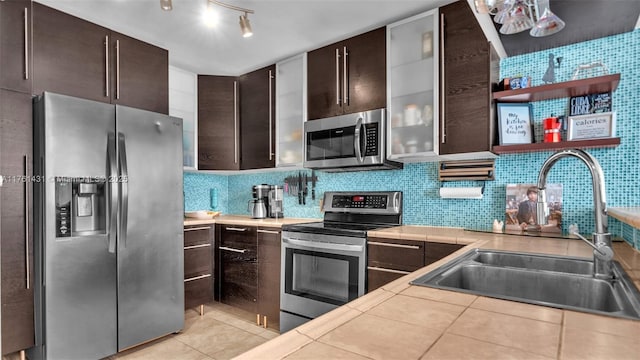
367;238;463;291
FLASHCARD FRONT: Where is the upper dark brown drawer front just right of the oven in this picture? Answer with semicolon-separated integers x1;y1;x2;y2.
367;238;425;271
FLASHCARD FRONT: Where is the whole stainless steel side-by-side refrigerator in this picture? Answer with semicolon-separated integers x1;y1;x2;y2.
30;93;184;359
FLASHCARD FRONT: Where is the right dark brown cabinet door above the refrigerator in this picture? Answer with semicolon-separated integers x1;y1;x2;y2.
110;32;169;114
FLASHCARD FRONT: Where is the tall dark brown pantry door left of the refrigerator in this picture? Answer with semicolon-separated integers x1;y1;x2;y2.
0;90;35;355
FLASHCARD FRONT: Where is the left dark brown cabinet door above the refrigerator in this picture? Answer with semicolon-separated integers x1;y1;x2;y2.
33;3;111;103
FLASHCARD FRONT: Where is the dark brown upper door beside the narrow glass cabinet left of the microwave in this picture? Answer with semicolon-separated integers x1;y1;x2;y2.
238;65;276;170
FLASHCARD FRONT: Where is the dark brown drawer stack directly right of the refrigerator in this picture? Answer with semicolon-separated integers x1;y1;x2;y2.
184;225;215;314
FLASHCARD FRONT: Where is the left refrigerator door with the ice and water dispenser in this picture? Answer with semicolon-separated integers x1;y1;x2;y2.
35;93;117;359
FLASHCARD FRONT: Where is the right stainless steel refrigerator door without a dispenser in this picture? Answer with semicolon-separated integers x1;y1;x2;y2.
116;105;184;350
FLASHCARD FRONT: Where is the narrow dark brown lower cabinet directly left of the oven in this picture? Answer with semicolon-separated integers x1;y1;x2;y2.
257;228;281;330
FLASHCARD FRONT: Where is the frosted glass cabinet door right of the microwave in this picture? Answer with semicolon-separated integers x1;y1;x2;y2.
387;9;439;162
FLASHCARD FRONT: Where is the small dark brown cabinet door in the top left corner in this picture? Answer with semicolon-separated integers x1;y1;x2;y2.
0;0;33;94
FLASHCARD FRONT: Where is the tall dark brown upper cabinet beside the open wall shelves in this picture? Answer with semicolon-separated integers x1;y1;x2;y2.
439;1;499;155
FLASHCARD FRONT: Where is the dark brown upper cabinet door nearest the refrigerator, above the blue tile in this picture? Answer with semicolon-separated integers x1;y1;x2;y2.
198;75;240;170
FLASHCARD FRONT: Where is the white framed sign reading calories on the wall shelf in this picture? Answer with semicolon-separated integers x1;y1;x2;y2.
567;112;616;141
